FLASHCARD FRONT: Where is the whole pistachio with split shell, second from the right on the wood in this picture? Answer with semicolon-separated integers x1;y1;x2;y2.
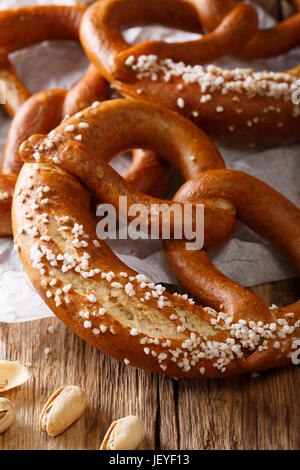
40;385;87;436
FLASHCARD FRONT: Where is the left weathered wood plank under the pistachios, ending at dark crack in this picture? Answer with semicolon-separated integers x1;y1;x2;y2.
0;319;158;449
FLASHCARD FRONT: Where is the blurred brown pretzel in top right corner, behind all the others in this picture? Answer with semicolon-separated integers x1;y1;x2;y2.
195;0;300;59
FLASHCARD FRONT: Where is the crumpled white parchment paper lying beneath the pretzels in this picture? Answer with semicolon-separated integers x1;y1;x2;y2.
0;0;300;322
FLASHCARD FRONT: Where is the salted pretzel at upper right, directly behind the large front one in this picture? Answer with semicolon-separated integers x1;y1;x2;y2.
80;0;300;144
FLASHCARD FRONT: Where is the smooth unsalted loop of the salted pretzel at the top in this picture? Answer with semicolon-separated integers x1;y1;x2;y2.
80;0;257;82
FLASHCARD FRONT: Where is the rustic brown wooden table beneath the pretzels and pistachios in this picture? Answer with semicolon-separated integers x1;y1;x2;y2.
0;279;300;450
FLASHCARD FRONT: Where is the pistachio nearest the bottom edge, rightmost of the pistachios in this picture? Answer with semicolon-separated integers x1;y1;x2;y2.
100;416;143;450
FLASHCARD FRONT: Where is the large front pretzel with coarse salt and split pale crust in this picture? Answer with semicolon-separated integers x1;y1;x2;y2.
13;100;300;377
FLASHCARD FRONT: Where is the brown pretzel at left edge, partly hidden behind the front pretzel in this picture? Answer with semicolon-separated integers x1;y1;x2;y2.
0;6;169;236
